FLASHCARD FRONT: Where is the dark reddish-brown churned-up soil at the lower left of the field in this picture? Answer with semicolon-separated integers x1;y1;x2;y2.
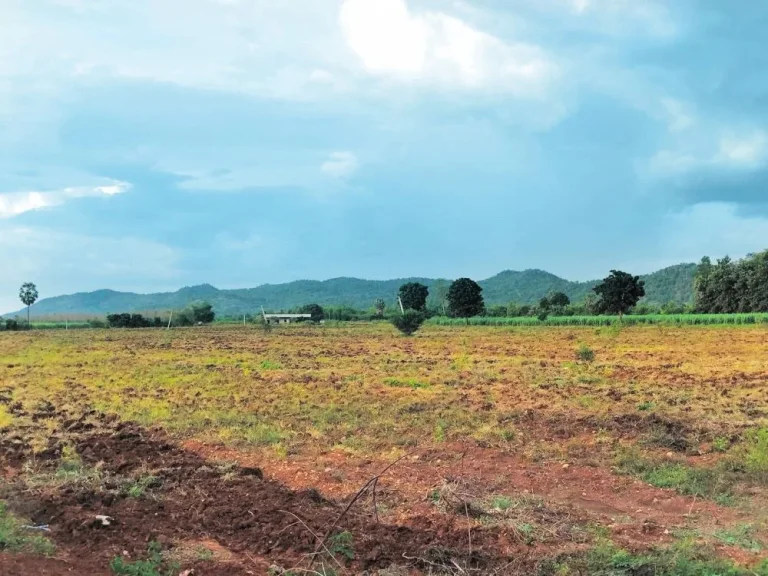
0;424;560;575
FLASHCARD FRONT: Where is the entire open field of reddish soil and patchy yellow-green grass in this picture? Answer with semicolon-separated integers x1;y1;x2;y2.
0;324;768;576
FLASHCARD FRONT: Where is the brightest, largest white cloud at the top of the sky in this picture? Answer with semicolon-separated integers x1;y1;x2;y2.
339;0;559;95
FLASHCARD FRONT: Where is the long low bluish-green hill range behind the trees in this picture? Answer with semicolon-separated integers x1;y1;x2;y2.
7;264;696;316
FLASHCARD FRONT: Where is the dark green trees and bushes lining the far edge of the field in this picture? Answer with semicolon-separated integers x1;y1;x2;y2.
0;250;768;333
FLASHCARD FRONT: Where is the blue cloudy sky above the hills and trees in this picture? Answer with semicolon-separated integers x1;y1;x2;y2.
0;0;768;311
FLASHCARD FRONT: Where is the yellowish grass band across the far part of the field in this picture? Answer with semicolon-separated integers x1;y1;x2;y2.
0;325;768;453
